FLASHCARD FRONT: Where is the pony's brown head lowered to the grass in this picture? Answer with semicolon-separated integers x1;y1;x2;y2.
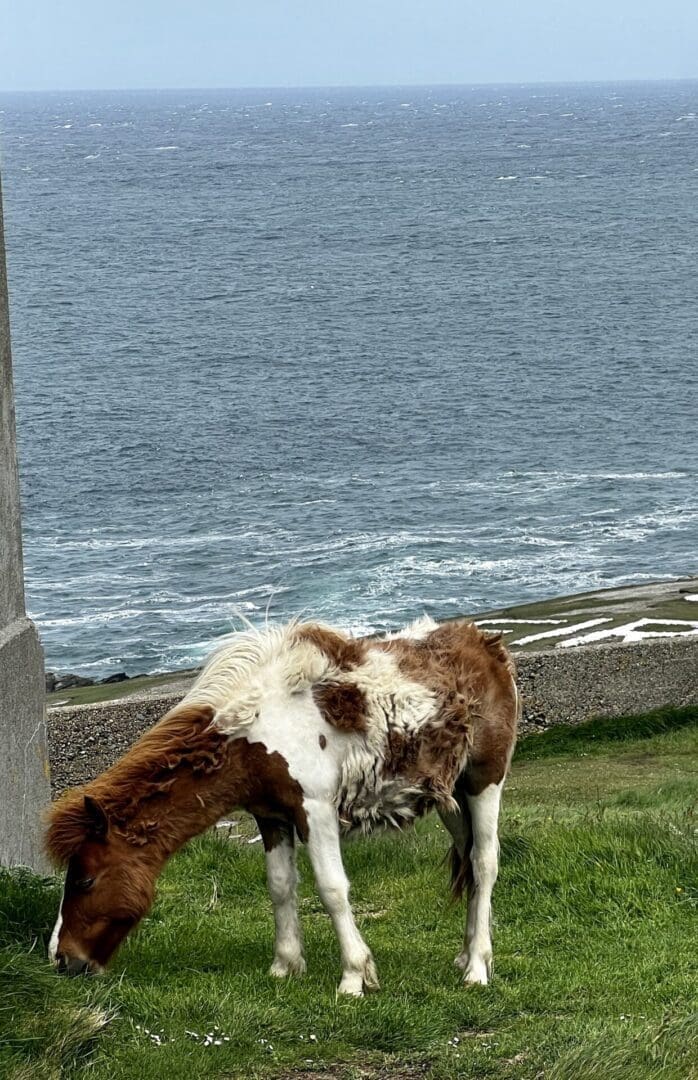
46;793;159;975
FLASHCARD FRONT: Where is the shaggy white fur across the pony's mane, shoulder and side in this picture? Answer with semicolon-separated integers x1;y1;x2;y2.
189;617;484;832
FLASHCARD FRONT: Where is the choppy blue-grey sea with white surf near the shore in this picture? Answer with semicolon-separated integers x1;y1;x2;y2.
0;83;698;675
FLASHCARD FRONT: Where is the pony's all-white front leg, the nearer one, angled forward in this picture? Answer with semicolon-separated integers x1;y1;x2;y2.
305;799;378;997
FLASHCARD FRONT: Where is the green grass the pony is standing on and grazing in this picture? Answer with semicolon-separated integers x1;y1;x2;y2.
0;711;698;1080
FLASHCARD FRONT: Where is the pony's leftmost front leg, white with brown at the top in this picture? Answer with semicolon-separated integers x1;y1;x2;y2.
256;818;306;978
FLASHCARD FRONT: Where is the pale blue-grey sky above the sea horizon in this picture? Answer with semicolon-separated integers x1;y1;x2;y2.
0;0;698;91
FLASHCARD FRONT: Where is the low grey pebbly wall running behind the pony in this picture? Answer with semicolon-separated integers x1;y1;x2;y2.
49;638;698;794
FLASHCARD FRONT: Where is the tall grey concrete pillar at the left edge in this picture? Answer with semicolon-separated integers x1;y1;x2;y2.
0;172;50;872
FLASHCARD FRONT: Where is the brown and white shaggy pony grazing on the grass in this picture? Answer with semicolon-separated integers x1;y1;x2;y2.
46;619;519;995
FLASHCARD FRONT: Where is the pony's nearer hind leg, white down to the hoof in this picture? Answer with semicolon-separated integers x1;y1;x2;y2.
456;780;504;986
